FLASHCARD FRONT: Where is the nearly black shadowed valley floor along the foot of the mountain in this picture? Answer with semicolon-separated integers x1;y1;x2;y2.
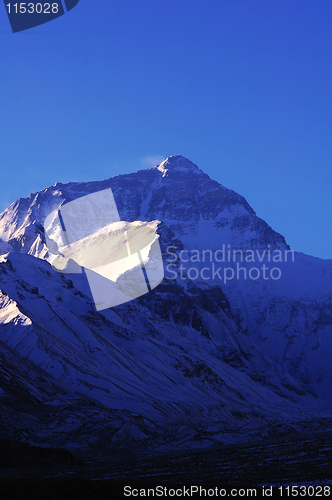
0;431;332;500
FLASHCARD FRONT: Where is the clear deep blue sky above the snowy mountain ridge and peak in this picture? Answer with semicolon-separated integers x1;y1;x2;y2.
0;0;332;258
